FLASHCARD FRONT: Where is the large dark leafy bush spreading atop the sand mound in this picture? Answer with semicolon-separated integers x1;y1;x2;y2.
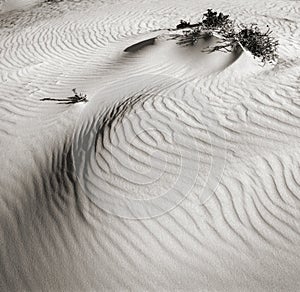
174;9;278;64
